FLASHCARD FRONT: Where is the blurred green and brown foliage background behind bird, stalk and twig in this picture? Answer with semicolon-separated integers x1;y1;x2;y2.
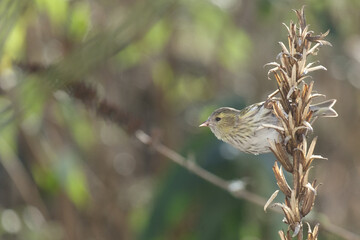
0;0;360;240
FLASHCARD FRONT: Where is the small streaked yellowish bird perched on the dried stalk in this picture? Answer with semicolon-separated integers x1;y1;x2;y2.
199;99;338;155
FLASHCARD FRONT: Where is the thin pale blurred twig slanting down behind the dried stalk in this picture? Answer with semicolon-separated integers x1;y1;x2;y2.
135;130;360;240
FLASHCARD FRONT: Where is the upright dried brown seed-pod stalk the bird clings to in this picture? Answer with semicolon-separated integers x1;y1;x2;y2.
267;7;337;240
